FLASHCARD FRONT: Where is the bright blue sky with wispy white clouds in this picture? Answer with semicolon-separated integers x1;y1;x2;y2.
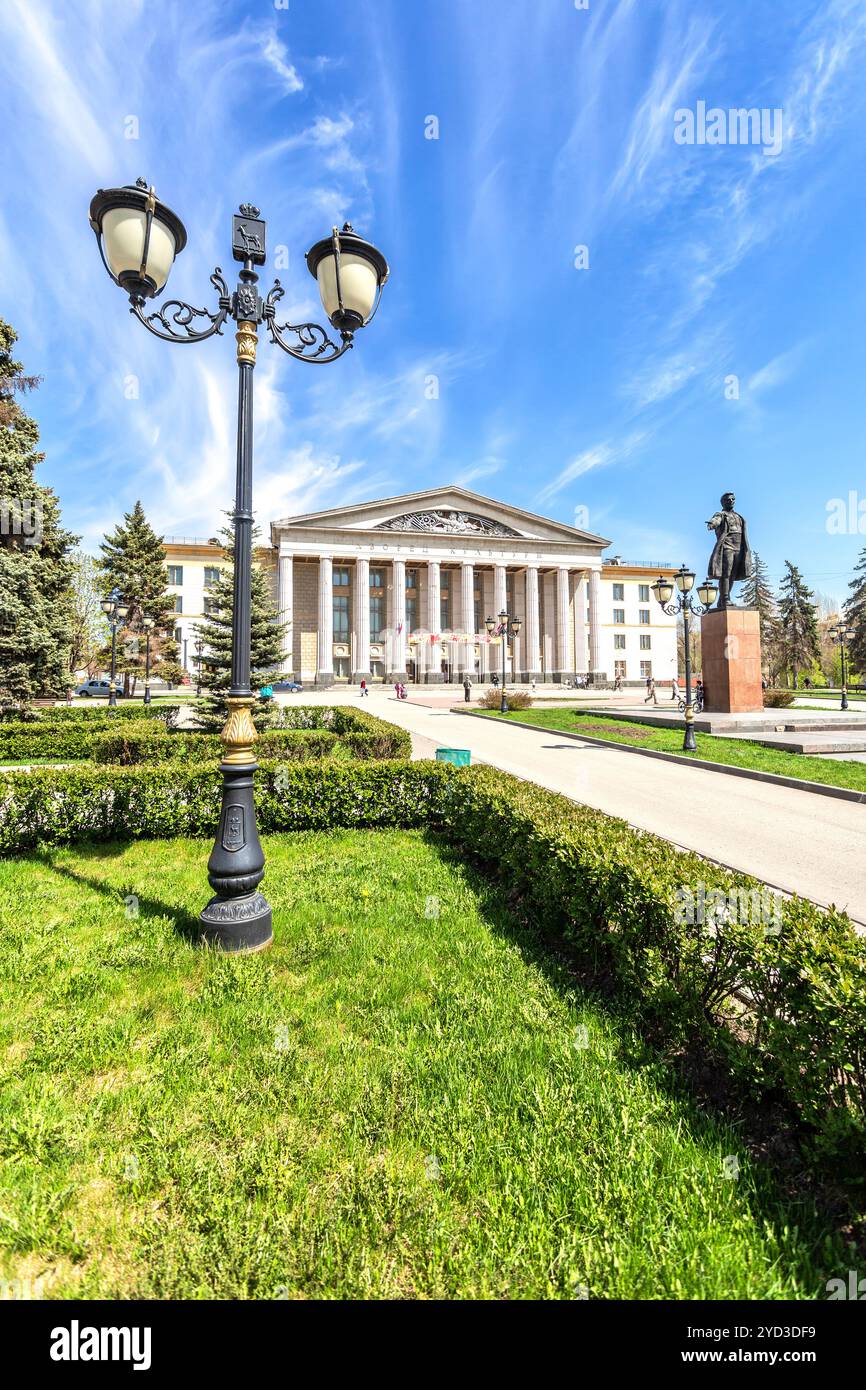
0;0;866;608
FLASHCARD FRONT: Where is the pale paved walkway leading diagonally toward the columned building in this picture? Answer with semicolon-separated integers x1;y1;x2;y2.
316;691;866;924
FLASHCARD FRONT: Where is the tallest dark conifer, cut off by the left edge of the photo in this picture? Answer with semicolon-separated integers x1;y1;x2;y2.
0;318;78;703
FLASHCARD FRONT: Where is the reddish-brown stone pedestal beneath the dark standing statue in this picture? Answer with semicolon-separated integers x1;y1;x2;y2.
701;607;763;714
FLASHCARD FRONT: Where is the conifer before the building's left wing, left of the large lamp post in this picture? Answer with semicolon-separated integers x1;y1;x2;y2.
99;502;178;695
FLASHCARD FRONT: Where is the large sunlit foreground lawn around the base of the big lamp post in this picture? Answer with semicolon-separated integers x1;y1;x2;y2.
0;831;848;1298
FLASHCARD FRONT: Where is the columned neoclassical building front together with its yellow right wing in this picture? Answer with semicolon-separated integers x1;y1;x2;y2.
271;485;677;687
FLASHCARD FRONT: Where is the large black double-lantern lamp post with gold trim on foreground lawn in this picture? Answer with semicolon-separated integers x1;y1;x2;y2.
90;179;388;952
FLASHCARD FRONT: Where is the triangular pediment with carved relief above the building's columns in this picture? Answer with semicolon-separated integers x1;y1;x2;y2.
271;484;610;552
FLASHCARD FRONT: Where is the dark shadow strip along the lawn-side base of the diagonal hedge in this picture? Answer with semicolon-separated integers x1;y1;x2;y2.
423;830;866;1297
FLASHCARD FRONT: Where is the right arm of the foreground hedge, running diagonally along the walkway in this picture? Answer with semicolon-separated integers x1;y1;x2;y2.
445;769;866;1166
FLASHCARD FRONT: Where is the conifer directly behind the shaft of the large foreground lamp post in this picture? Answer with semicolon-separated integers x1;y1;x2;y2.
196;521;284;733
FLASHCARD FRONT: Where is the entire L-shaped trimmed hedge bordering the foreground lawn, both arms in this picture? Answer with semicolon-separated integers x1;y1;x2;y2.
0;756;866;1166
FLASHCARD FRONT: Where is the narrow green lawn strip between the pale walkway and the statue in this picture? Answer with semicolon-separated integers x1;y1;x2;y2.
480;708;866;791
